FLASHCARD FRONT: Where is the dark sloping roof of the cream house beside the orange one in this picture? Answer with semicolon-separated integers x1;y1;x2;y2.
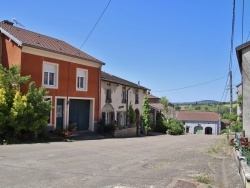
101;71;148;90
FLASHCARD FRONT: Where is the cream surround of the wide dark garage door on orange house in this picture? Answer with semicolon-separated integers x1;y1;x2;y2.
67;97;95;131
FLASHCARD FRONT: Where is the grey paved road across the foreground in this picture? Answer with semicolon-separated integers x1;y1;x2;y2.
0;135;241;188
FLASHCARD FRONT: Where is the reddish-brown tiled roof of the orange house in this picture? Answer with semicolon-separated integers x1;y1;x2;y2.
0;21;104;64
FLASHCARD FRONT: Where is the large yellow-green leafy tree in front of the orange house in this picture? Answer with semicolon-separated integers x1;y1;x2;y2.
0;65;52;141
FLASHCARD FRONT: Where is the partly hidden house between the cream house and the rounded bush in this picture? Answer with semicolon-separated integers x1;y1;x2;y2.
147;93;175;126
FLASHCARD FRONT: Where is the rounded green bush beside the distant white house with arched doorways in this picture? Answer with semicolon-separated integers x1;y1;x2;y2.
167;118;185;135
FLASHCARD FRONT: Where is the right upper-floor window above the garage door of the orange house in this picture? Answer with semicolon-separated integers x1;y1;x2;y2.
76;68;88;91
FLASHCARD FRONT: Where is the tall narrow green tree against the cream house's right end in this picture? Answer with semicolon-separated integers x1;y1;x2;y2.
142;95;151;135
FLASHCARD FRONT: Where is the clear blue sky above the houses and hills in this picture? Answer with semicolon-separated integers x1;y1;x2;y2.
0;0;250;102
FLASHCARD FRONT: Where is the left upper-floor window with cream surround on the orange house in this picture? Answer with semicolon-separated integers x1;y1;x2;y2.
43;62;58;88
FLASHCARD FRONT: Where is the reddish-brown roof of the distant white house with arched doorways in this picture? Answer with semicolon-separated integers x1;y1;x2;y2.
177;111;220;122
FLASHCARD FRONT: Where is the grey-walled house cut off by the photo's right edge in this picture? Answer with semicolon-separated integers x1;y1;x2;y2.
236;41;250;138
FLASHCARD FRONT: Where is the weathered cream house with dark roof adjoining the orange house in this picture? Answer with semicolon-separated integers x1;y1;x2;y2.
100;72;148;126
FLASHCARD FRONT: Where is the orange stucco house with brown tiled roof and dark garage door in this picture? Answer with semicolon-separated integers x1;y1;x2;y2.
0;21;104;131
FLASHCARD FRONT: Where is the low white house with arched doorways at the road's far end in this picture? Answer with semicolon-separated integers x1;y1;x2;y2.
176;111;221;135
